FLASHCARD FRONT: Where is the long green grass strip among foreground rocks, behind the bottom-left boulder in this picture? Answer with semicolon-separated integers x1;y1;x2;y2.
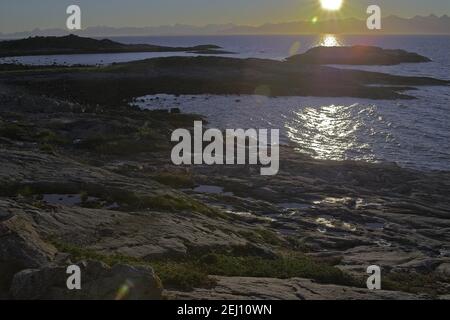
51;240;361;290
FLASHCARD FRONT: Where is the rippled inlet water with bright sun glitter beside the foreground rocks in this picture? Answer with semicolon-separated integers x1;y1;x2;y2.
134;87;450;170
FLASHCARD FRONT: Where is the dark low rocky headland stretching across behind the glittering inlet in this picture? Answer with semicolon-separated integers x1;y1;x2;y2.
4;57;449;101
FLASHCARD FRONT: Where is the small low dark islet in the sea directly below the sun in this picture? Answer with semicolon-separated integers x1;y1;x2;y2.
287;46;431;65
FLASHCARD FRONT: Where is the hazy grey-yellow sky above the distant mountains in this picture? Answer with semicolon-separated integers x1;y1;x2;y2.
0;0;450;33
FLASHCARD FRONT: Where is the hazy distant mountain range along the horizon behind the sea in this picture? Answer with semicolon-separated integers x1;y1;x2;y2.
0;15;450;38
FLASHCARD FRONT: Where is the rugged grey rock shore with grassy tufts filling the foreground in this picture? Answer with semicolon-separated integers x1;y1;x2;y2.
0;76;450;299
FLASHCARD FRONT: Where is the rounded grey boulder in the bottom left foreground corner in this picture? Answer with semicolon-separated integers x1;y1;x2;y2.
11;261;162;300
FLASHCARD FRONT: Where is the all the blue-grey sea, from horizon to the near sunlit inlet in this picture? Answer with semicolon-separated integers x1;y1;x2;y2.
0;35;450;171
